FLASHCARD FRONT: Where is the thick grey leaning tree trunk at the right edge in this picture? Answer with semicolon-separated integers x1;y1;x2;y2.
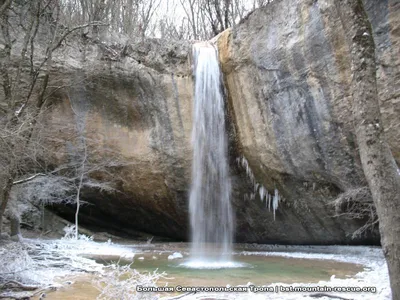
335;0;400;300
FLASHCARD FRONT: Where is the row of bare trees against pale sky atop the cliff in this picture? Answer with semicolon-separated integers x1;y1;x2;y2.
56;0;270;40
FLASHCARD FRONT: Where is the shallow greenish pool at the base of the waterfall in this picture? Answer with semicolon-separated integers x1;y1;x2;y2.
96;252;363;286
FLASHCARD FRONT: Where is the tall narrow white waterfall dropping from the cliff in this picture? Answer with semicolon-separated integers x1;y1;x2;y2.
189;43;234;264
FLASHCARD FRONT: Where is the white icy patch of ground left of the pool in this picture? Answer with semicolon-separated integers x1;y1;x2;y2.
3;239;135;284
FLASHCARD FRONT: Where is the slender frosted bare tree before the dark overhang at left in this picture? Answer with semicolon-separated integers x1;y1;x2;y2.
8;113;126;238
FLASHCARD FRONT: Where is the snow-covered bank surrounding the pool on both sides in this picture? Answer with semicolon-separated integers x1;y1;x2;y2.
0;237;390;300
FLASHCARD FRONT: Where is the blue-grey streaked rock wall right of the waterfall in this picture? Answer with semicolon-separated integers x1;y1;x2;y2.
217;0;400;243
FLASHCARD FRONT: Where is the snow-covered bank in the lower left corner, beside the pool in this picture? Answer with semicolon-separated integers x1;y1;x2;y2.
0;236;135;298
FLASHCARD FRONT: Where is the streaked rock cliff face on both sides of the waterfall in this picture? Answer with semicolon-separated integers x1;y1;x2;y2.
35;0;400;244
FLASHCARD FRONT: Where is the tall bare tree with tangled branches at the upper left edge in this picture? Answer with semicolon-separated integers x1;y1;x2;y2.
0;0;108;234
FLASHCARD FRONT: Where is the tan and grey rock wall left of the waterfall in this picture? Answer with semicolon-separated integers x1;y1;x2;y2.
42;40;193;239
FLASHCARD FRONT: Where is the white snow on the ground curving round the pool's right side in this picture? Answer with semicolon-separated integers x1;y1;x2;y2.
181;245;391;300
